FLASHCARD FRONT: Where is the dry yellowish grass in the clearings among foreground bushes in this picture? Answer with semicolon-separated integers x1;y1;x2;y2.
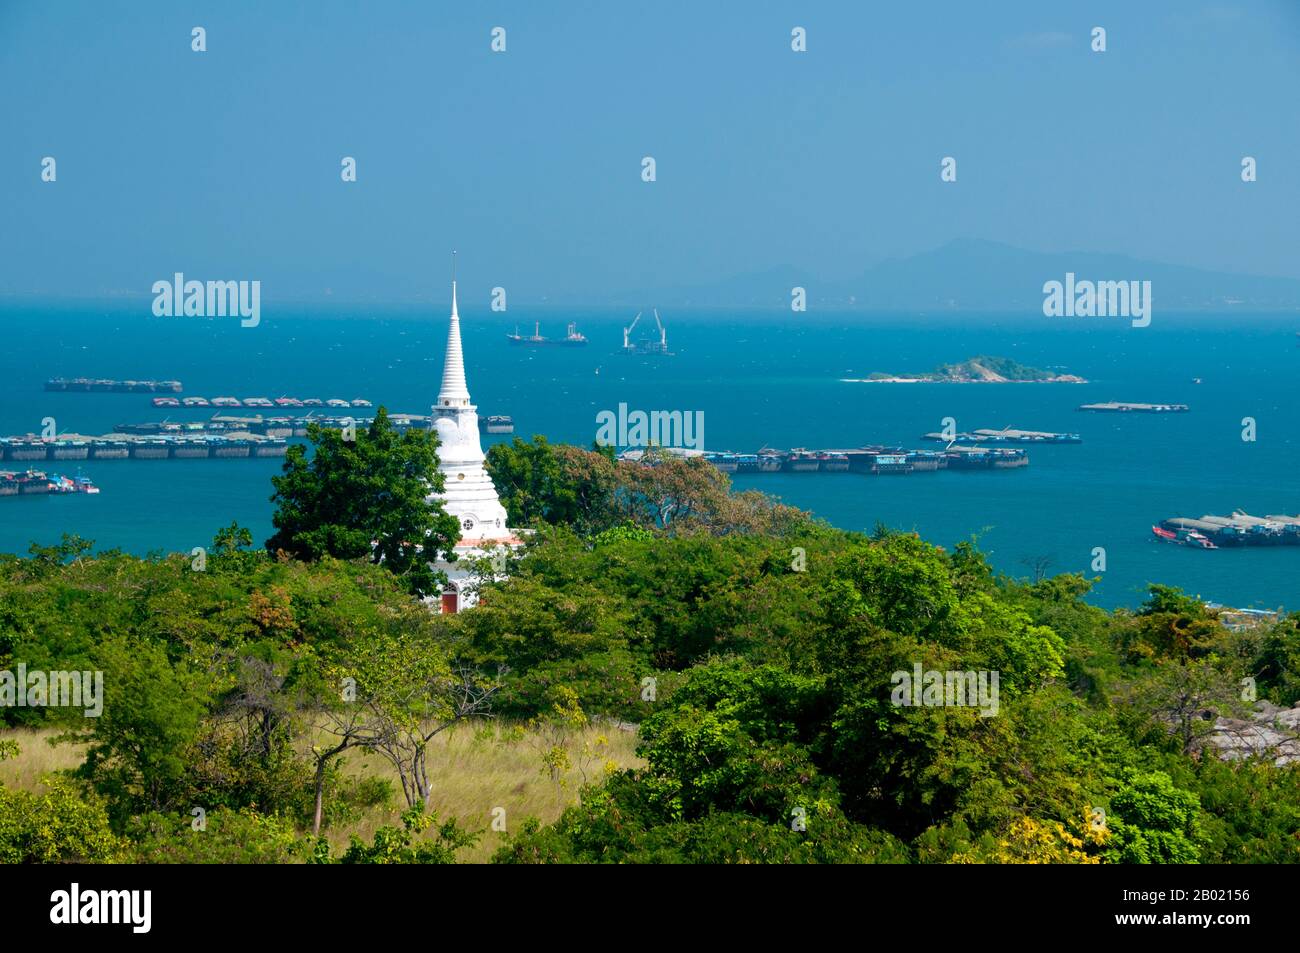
0;720;642;863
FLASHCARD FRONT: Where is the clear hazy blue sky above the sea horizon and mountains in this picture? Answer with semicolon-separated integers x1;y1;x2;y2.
0;0;1300;302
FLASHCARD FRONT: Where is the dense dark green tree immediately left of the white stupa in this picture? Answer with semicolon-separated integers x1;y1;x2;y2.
267;407;460;595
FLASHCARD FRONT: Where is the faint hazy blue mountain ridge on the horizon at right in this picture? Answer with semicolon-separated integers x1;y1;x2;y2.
616;239;1300;311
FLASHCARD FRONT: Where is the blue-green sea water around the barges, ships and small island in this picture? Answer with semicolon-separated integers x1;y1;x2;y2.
0;299;1300;607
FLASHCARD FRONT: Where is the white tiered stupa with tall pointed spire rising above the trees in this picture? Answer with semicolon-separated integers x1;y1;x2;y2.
428;259;523;612
